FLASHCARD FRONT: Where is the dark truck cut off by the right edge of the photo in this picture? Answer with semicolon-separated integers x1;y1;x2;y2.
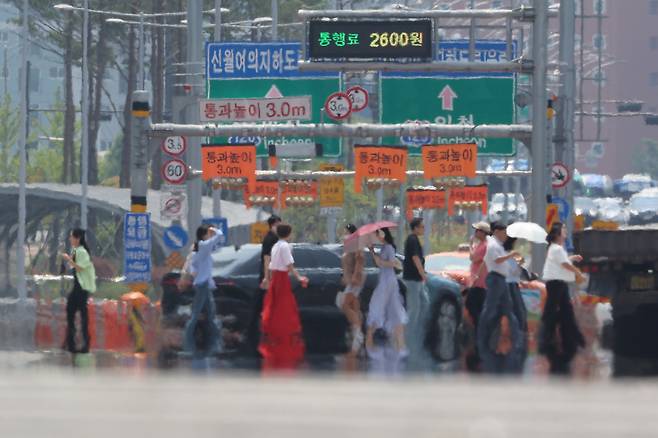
573;224;658;376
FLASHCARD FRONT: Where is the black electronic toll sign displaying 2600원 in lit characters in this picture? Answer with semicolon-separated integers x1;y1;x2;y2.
308;18;434;62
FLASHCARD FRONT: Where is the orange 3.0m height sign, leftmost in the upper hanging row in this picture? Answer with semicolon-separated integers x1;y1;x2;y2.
201;145;256;192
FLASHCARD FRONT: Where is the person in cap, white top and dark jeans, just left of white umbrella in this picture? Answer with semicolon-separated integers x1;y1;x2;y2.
477;222;520;373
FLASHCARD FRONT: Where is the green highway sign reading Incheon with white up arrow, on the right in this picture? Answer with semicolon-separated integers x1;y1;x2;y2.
380;77;515;156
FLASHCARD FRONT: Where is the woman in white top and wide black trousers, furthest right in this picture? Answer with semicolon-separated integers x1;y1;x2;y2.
539;222;585;374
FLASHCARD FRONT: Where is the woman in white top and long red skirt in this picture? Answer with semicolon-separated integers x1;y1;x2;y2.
258;224;308;369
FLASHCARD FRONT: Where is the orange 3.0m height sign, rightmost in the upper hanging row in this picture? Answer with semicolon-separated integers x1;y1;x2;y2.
423;143;478;179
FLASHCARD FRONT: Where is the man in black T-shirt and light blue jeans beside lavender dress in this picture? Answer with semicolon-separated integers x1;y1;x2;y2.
402;218;429;352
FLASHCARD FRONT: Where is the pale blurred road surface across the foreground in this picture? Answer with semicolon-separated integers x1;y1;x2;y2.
0;368;658;438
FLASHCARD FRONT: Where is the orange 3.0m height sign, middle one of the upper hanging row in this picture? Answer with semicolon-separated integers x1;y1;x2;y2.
354;145;407;193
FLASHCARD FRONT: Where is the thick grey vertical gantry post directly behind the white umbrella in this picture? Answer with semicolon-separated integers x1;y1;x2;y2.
530;0;548;272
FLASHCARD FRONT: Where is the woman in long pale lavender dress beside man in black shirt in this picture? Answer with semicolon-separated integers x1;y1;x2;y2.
366;228;407;352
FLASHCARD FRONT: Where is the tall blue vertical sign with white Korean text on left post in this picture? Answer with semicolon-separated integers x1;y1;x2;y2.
123;213;151;283
